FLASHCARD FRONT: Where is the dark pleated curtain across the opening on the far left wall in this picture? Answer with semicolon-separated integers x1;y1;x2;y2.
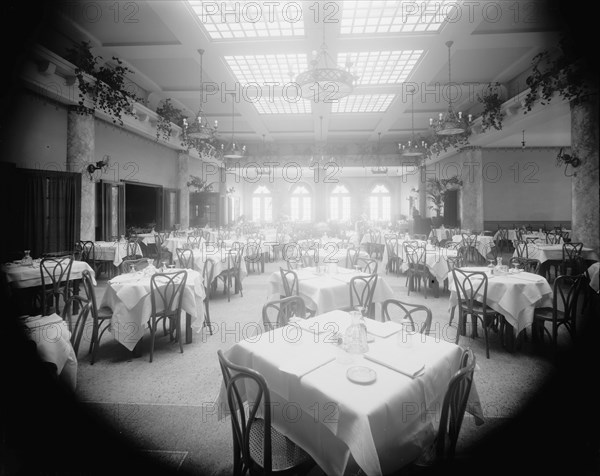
22;170;81;257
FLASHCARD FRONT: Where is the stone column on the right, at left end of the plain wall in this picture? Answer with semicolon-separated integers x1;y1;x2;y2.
458;148;484;231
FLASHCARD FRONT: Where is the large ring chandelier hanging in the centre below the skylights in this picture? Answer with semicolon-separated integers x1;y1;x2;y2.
296;35;356;103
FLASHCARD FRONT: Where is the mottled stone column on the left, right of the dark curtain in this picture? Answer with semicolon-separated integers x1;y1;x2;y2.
67;109;99;241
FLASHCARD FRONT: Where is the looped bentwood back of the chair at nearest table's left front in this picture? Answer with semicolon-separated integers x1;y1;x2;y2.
217;350;273;474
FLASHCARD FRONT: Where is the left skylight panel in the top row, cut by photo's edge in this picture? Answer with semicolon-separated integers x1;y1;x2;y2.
188;0;304;40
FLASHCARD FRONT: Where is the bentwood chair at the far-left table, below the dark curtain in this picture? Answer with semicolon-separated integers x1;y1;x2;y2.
40;254;73;315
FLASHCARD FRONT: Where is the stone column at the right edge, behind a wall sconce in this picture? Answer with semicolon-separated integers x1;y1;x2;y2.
569;96;600;253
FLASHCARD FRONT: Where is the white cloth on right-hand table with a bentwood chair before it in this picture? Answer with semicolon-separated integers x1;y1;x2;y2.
448;267;552;335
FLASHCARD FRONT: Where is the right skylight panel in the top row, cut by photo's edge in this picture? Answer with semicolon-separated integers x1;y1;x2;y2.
340;0;456;35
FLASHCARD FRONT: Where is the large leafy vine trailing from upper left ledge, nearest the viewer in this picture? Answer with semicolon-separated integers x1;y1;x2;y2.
66;41;140;126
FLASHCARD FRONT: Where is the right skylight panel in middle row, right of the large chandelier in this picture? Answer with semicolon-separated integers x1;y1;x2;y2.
337;50;423;85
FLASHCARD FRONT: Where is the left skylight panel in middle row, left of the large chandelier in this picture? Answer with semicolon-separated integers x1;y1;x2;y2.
225;54;308;86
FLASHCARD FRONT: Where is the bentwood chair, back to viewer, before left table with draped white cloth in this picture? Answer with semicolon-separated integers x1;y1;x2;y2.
148;271;187;362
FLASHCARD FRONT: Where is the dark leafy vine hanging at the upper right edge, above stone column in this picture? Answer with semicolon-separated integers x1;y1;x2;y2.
523;37;598;114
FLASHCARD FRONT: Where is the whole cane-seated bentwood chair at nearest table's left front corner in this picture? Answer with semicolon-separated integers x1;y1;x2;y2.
217;350;315;476
